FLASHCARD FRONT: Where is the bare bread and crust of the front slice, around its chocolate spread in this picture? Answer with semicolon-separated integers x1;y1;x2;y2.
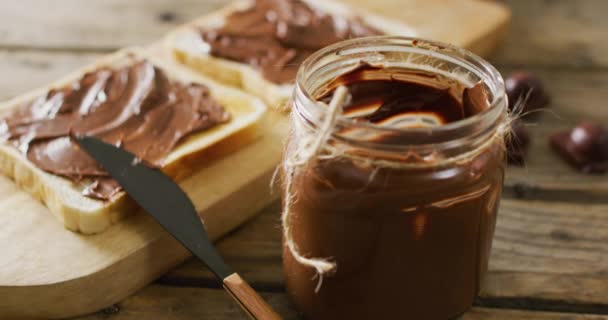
0;49;266;234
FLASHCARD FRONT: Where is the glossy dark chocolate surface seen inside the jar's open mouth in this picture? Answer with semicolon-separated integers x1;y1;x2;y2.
318;63;488;128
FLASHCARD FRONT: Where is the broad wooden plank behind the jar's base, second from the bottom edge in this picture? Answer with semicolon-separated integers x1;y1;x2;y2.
161;199;608;312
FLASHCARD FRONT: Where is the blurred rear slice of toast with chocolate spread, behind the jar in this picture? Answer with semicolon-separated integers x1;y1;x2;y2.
165;0;415;107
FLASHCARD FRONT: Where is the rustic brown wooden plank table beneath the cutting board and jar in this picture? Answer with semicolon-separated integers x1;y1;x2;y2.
0;0;608;320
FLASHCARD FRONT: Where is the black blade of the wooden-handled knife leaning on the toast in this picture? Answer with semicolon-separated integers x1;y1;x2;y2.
76;136;233;280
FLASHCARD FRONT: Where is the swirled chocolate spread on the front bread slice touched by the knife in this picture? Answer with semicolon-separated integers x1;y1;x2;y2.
2;61;230;200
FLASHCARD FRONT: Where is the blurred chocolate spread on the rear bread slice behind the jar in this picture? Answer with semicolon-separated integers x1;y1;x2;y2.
202;0;381;84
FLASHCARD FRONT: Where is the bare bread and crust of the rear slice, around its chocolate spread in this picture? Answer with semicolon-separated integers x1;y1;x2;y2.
165;0;416;109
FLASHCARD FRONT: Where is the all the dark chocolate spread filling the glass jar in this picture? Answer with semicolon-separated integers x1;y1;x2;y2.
284;66;505;320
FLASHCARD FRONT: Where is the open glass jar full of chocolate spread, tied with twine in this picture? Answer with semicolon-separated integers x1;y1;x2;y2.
282;37;508;319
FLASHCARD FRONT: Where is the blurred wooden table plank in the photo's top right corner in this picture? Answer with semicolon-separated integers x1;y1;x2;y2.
494;0;608;68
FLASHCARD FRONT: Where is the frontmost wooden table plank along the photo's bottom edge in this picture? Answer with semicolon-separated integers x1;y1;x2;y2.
79;285;608;320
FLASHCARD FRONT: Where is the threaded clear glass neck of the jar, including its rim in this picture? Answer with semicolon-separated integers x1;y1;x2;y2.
293;37;507;161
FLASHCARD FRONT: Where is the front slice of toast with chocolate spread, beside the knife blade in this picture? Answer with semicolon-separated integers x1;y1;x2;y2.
0;49;266;234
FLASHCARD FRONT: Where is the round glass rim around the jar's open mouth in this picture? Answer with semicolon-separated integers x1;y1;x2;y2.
294;36;507;146
